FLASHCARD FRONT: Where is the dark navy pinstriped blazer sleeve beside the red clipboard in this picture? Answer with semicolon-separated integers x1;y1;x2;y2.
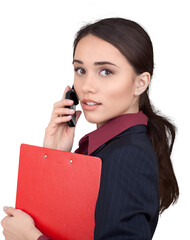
94;145;159;240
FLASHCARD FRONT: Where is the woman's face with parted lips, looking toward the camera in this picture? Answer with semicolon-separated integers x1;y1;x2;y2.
73;34;139;127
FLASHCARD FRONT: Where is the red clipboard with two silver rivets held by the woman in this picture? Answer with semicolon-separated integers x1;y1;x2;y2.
16;144;102;240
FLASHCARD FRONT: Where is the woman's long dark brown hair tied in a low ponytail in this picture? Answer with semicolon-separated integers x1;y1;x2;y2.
73;18;179;213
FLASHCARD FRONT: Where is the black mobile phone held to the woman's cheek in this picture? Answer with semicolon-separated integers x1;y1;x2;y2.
65;85;79;127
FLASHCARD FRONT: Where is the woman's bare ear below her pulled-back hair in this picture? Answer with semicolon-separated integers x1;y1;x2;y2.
135;72;151;96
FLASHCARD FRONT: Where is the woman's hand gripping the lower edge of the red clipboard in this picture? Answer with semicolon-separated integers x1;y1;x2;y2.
1;207;42;240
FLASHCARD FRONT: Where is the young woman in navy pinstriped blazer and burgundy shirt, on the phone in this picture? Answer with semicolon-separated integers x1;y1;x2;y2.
2;18;179;240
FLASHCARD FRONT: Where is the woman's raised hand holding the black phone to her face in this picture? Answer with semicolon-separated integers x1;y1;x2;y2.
43;86;81;152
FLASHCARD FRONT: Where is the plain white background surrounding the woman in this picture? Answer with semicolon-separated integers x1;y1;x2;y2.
0;0;190;240
